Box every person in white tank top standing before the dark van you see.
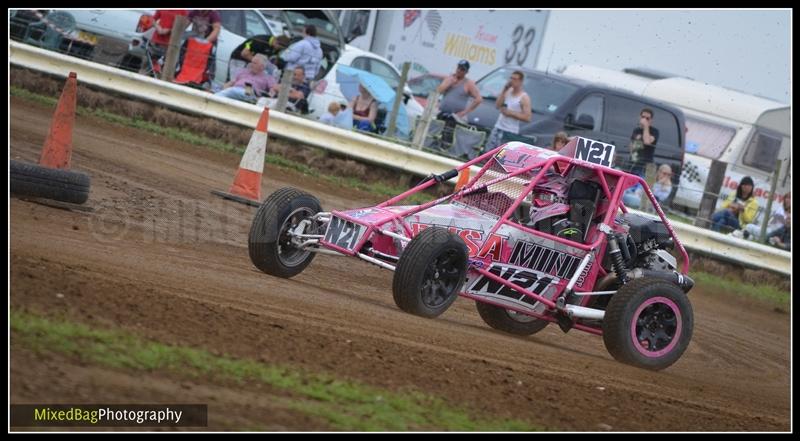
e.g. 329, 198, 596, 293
486, 70, 531, 150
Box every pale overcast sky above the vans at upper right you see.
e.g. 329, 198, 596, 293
537, 10, 791, 103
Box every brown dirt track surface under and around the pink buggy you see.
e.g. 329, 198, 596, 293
10, 98, 790, 431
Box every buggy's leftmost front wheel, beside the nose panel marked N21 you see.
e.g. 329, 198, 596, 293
252, 188, 322, 279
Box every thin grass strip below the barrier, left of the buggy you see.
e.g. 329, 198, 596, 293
10, 86, 432, 204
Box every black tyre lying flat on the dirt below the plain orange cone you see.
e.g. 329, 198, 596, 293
9, 160, 92, 204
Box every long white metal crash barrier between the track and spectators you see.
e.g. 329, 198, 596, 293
8, 41, 791, 275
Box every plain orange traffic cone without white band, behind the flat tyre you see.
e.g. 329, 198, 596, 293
39, 72, 78, 169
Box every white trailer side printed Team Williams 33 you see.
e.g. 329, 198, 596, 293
339, 9, 549, 79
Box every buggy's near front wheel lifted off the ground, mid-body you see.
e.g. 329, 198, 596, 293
392, 227, 469, 318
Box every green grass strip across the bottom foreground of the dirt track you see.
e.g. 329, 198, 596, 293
10, 310, 541, 431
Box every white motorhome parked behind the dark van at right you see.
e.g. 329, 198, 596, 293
562, 64, 792, 222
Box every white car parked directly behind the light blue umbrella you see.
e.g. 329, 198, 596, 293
308, 44, 425, 132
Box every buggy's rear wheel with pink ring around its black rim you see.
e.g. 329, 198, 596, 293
603, 278, 694, 370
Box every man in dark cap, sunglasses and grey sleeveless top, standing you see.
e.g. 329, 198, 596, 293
436, 60, 483, 144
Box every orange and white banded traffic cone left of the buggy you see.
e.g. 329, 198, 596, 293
211, 107, 269, 207
